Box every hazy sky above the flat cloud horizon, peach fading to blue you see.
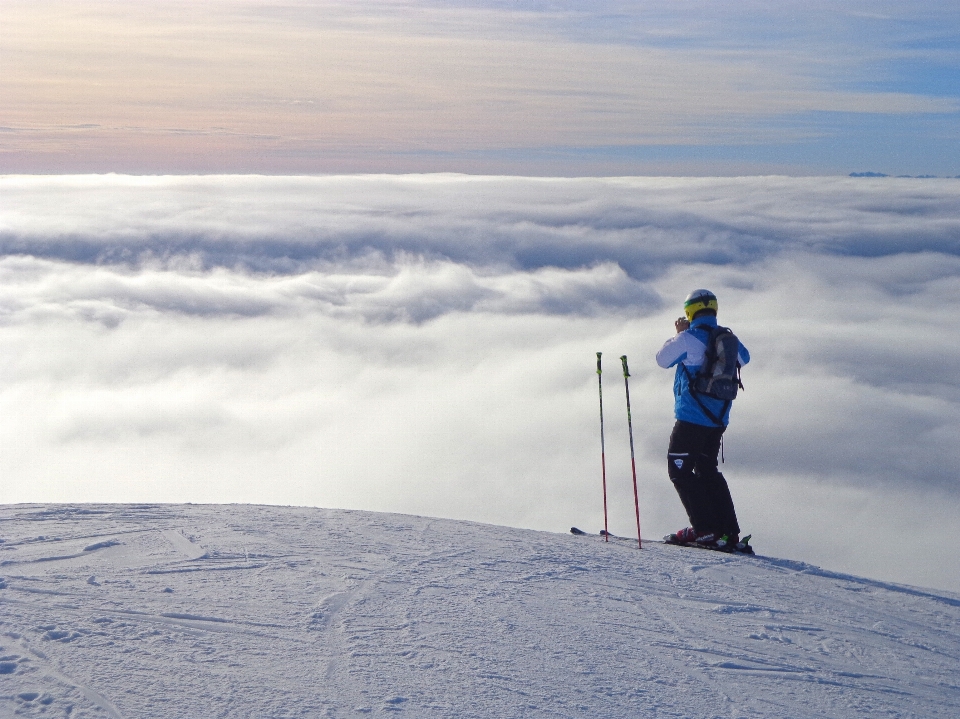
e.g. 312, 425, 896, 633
0, 0, 960, 176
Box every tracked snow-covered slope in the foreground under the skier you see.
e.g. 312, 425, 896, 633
0, 505, 960, 719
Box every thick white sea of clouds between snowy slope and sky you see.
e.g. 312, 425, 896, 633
0, 175, 960, 589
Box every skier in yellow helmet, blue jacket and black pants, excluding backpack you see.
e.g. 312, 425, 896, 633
657, 290, 750, 549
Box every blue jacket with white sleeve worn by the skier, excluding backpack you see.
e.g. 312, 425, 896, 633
657, 315, 750, 427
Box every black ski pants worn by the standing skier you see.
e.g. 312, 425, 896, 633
667, 420, 740, 538
